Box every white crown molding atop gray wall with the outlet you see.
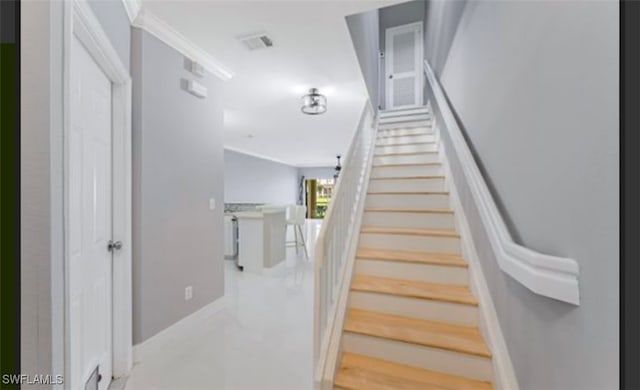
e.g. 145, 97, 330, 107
131, 8, 234, 80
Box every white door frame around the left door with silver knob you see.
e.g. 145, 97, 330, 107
62, 0, 133, 387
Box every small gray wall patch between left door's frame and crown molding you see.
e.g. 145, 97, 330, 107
88, 0, 131, 69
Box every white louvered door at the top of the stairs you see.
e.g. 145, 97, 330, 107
385, 22, 423, 109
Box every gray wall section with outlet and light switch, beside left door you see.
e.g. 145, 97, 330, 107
131, 28, 224, 344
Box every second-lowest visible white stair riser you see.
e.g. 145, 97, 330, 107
349, 291, 478, 326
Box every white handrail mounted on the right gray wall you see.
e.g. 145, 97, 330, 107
424, 60, 580, 305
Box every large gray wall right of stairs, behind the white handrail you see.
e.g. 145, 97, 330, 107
428, 1, 619, 390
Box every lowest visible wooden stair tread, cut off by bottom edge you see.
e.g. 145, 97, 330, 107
335, 352, 492, 390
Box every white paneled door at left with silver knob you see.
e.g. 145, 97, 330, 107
67, 36, 112, 390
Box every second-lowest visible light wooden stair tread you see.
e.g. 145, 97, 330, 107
344, 309, 491, 358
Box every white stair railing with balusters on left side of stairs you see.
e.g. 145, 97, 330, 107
313, 101, 376, 388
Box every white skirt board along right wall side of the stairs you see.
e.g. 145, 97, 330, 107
439, 142, 520, 390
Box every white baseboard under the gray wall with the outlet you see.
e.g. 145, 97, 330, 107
133, 296, 227, 363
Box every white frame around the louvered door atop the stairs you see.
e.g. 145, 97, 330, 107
384, 21, 424, 110
